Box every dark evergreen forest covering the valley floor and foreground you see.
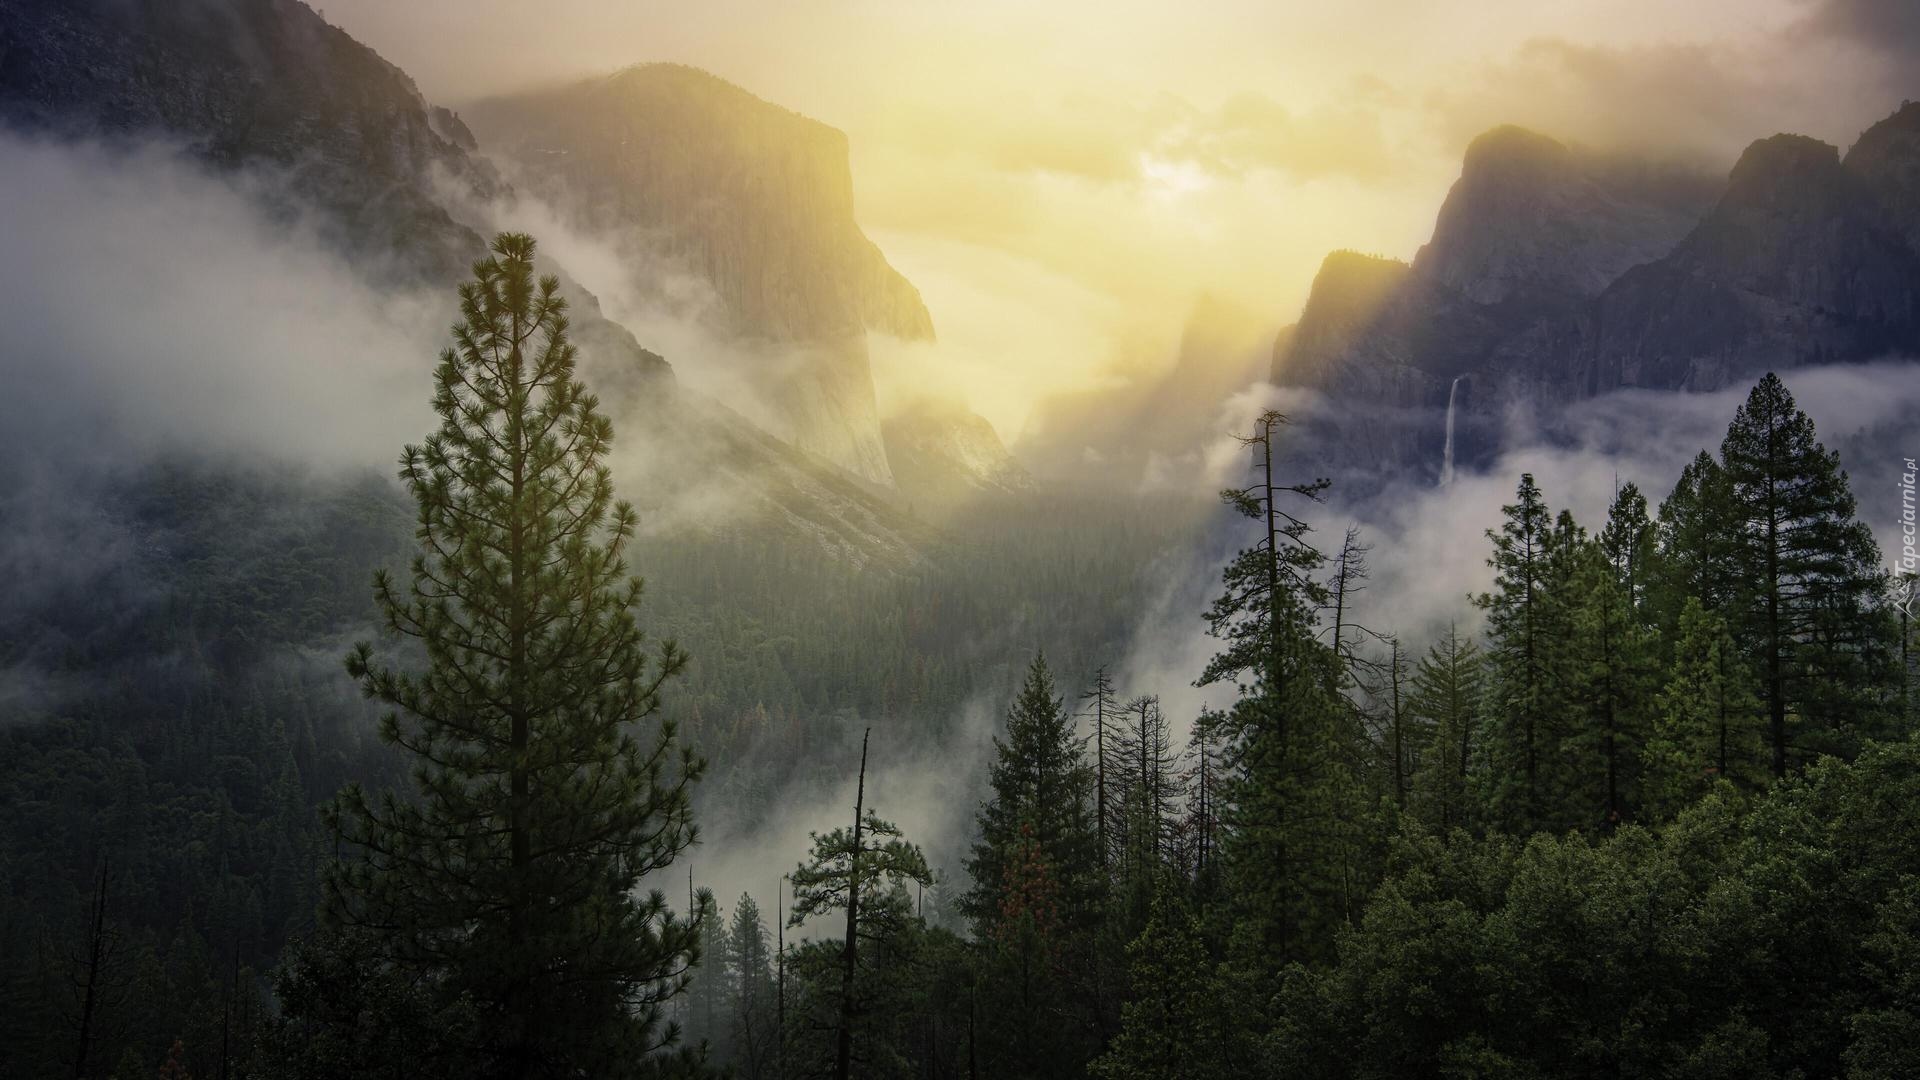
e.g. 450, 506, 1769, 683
0, 236, 1920, 1080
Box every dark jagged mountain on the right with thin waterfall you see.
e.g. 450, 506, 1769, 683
1273, 106, 1920, 479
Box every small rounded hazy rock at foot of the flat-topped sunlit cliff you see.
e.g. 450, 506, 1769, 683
881, 400, 1035, 511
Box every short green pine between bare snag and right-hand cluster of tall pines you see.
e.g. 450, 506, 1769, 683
1407, 625, 1484, 832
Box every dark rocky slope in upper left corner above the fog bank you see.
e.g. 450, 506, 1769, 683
0, 0, 499, 281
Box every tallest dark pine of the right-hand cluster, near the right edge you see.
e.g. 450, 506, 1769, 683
1720, 373, 1893, 776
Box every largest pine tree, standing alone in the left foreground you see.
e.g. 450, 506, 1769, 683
326, 234, 701, 1076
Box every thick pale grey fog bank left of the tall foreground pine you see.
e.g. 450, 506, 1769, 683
0, 136, 451, 465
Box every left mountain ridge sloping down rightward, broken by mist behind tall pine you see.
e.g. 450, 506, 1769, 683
0, 0, 927, 565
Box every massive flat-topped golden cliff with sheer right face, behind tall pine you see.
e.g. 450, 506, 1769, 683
465, 63, 933, 484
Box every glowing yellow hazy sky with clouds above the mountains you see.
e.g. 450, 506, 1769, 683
324, 0, 1920, 434
